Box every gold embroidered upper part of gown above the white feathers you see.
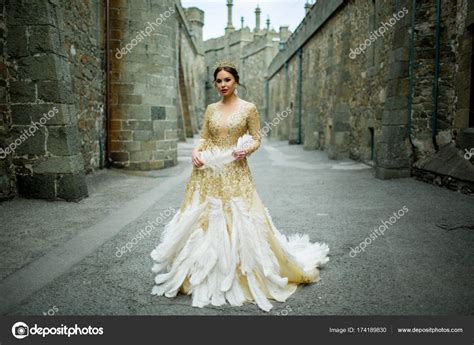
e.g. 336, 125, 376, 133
181, 100, 261, 210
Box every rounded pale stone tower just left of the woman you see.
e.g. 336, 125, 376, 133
110, 0, 178, 170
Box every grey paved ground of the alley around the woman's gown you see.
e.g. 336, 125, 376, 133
0, 138, 474, 315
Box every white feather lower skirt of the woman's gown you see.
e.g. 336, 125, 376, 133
151, 185, 329, 311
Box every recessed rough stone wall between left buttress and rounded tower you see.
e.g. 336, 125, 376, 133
58, 0, 106, 173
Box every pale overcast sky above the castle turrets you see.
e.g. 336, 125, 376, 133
181, 0, 315, 40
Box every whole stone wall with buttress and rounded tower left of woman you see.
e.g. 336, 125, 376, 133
0, 0, 204, 200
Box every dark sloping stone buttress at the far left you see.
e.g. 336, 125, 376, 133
2, 0, 87, 200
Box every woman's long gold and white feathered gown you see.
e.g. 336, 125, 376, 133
151, 100, 329, 311
